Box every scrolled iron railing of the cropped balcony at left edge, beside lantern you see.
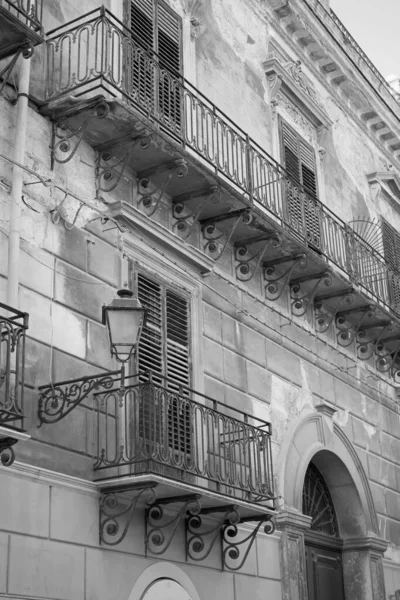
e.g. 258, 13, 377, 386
0, 303, 28, 429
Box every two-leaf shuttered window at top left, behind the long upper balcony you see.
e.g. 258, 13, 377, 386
125, 0, 182, 129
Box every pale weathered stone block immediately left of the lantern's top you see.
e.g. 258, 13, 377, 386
54, 261, 115, 321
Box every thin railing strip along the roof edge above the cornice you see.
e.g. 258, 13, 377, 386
305, 0, 400, 115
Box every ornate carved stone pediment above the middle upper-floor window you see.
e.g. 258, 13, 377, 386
263, 56, 332, 130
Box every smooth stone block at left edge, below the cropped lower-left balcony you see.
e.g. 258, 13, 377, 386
0, 474, 49, 537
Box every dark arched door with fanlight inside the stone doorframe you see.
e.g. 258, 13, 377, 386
303, 462, 344, 600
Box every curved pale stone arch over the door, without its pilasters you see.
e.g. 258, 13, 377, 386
277, 406, 379, 539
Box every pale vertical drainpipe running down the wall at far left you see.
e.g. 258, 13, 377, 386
7, 56, 31, 308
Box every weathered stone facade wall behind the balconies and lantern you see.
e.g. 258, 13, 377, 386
0, 0, 400, 600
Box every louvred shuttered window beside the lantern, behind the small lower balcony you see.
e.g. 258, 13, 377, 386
137, 273, 191, 454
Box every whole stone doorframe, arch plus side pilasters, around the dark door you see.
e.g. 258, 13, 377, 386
276, 404, 387, 600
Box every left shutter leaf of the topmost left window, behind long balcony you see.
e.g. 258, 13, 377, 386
128, 0, 155, 110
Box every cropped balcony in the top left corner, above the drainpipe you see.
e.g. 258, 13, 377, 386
0, 0, 44, 60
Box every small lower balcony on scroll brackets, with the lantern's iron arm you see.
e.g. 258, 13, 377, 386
39, 370, 275, 570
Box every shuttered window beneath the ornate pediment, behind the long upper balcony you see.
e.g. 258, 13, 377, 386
280, 119, 321, 249
